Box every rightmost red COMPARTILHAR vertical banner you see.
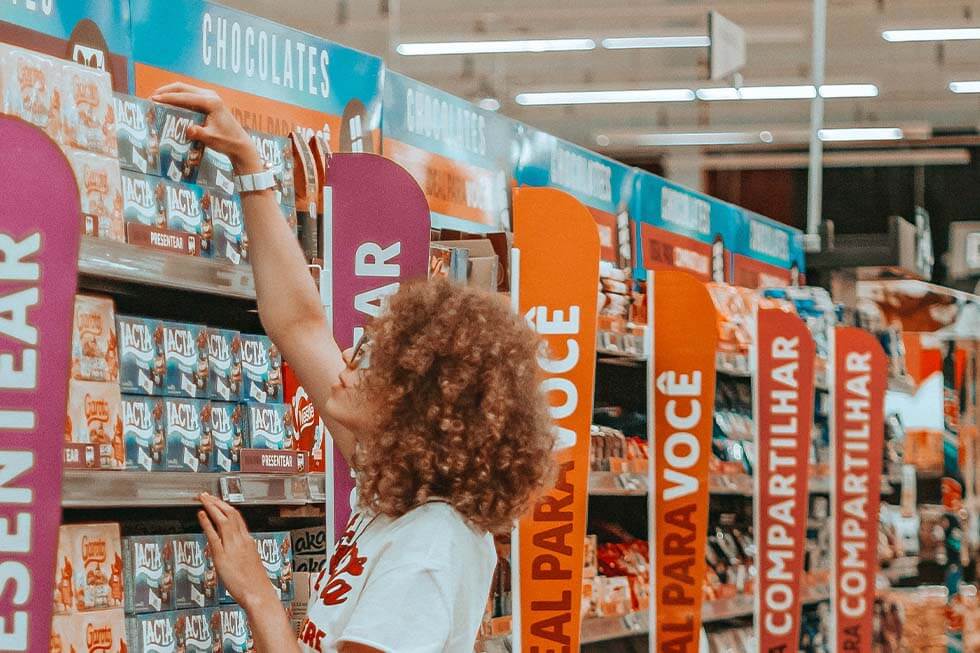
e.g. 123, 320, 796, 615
830, 327, 888, 653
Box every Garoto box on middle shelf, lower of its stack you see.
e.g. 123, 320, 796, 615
65, 379, 126, 469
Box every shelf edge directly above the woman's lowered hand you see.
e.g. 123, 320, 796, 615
61, 470, 310, 508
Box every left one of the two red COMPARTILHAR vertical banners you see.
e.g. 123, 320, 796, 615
753, 309, 815, 653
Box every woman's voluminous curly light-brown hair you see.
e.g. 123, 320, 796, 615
355, 279, 554, 533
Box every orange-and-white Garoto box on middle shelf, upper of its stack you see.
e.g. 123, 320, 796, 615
71, 295, 119, 382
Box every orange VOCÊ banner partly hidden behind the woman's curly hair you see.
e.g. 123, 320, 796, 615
513, 188, 599, 653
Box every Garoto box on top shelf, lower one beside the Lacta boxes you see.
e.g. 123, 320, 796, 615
68, 149, 126, 242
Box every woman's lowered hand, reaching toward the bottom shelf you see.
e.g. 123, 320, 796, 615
197, 492, 278, 610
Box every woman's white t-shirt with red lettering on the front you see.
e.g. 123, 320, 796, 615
299, 502, 497, 653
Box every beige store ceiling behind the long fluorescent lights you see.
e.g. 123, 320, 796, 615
225, 0, 980, 153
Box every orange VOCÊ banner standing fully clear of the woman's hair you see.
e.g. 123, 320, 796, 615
647, 271, 718, 653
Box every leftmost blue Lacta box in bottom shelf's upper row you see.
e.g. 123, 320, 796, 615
123, 535, 174, 614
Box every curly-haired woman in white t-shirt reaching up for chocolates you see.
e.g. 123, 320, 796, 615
153, 84, 554, 653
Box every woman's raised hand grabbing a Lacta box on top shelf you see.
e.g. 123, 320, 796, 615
150, 82, 263, 174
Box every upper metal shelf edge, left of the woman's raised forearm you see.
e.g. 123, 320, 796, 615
78, 236, 255, 299
